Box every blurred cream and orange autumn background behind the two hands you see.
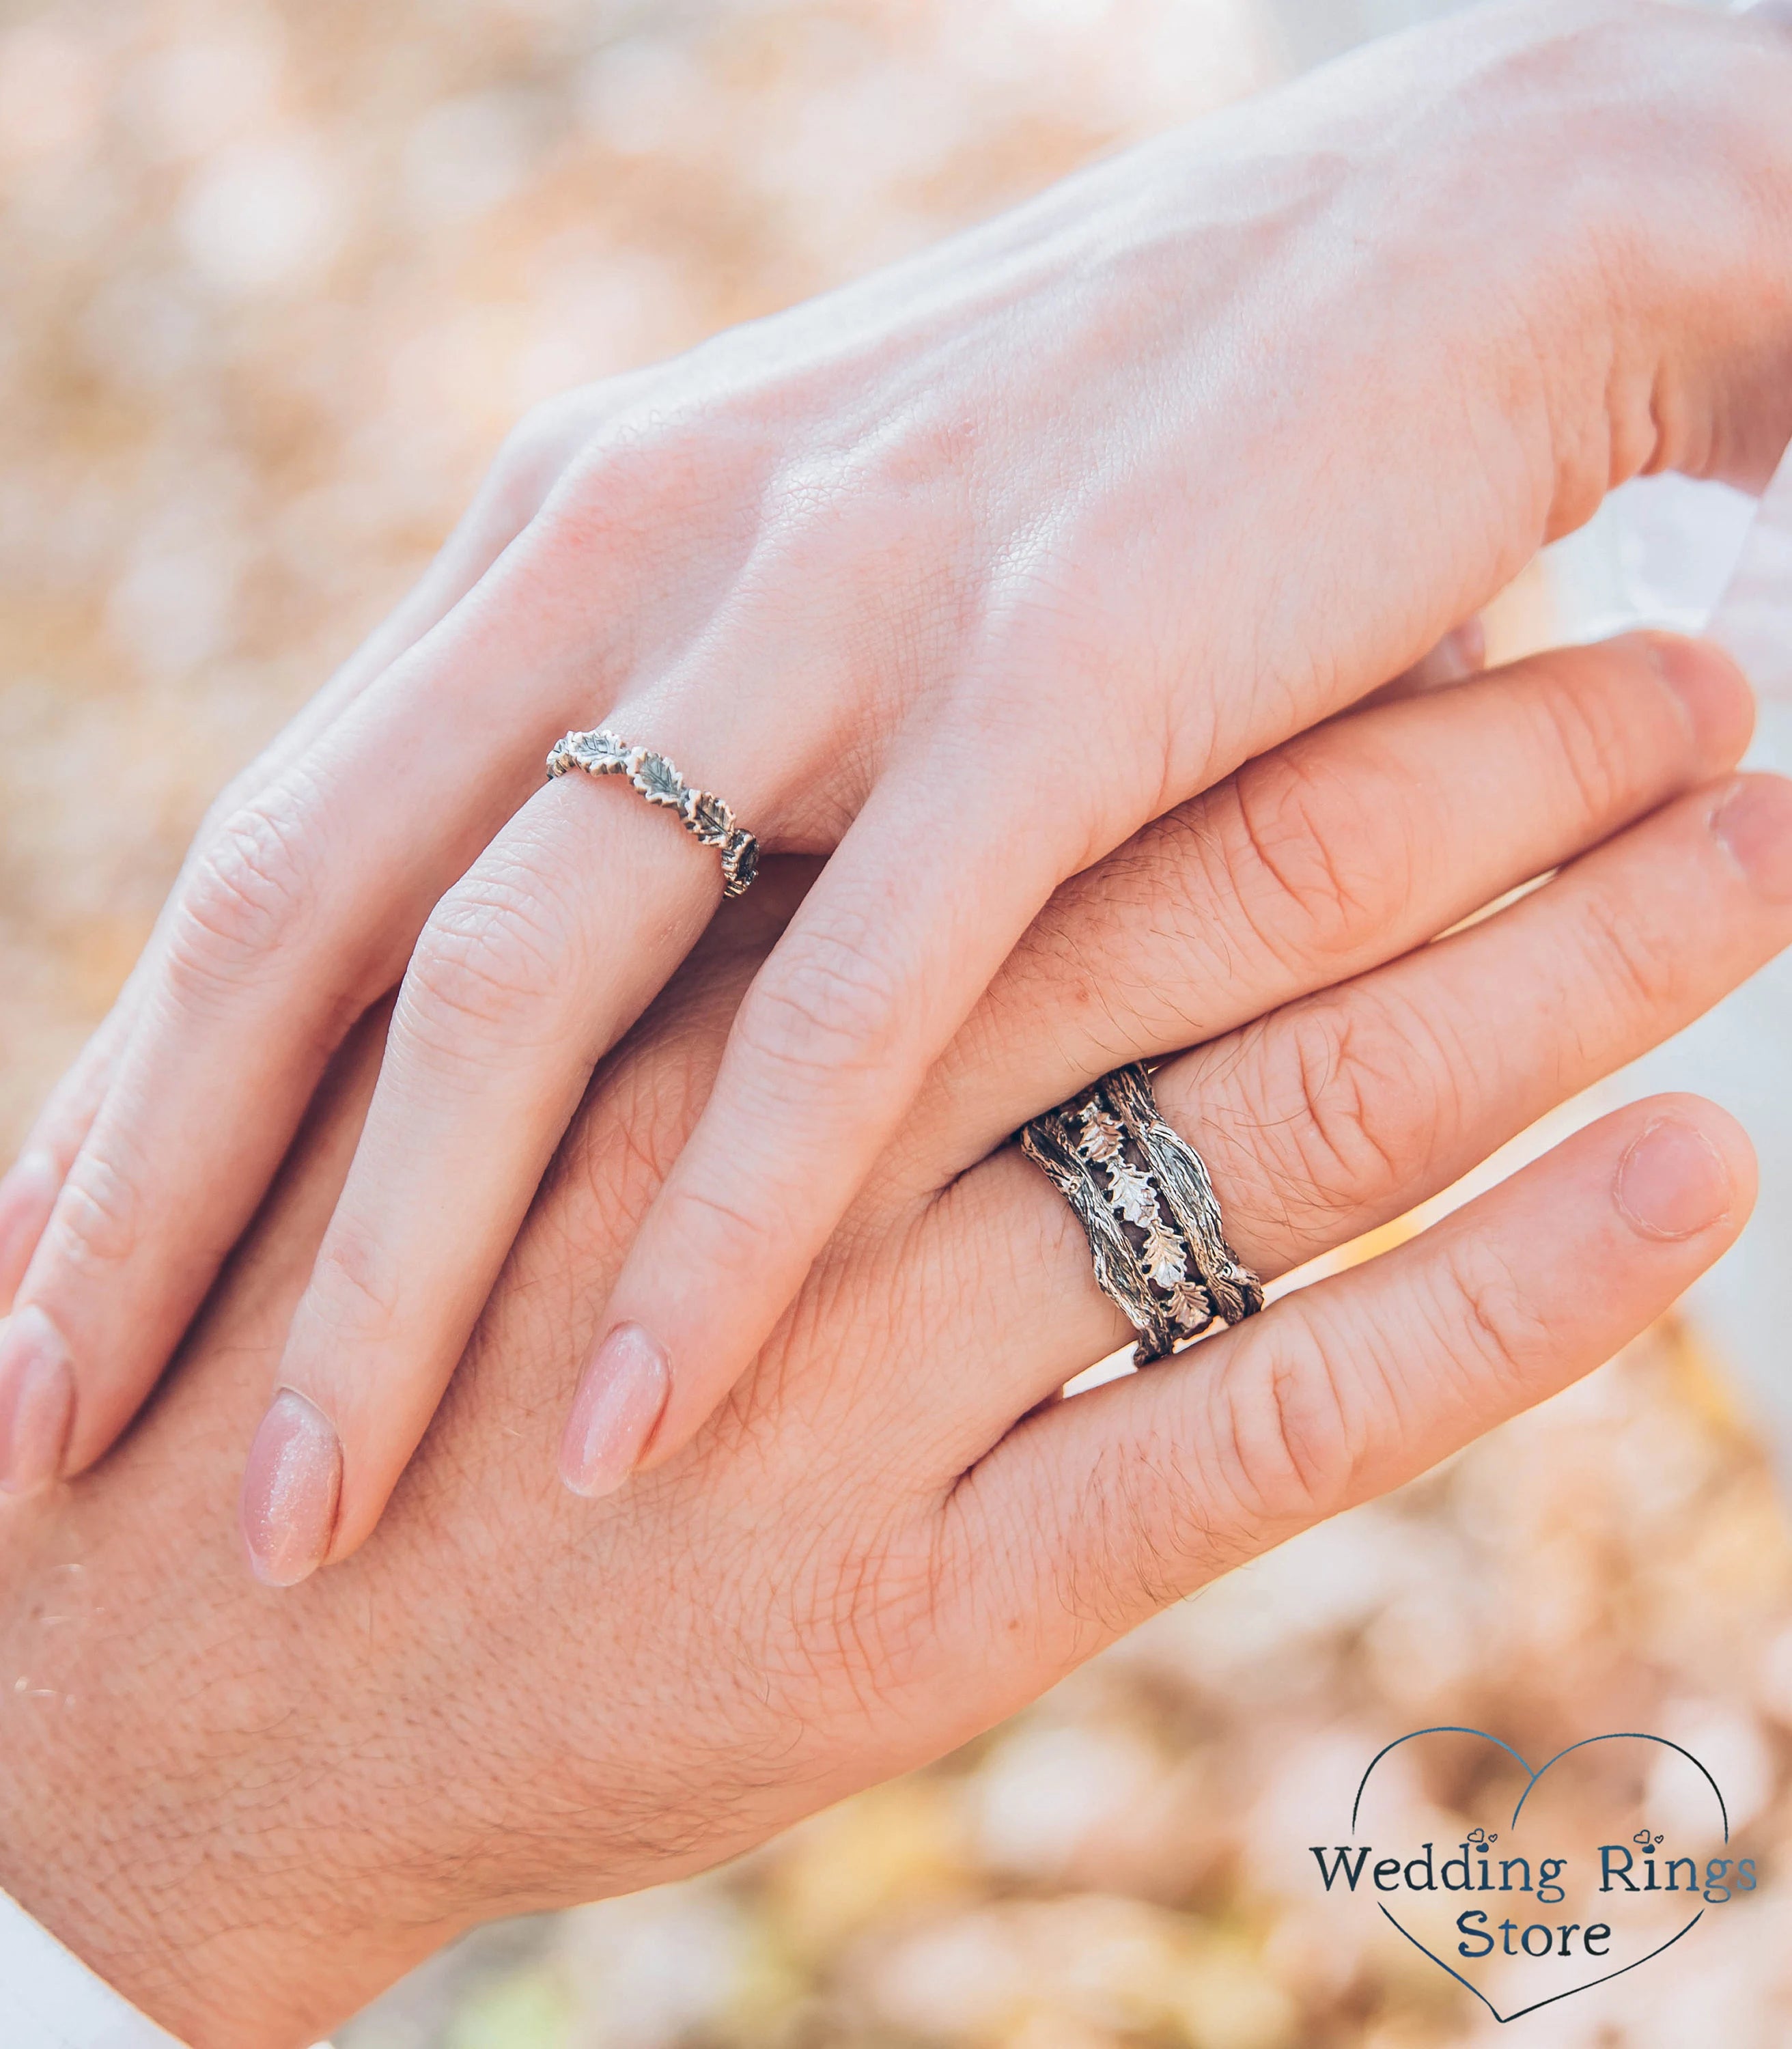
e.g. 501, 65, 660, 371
0, 0, 1792, 2049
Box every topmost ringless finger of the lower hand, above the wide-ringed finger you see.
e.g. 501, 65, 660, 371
883, 633, 1753, 1193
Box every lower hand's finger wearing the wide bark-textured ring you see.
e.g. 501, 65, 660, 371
932, 777, 1792, 1434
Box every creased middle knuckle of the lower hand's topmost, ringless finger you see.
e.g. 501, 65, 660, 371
1224, 746, 1415, 963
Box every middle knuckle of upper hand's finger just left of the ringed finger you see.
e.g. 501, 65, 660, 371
168, 797, 316, 988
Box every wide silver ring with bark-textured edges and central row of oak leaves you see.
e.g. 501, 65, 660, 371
1020, 1065, 1263, 1367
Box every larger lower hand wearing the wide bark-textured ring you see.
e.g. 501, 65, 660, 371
0, 637, 1792, 2049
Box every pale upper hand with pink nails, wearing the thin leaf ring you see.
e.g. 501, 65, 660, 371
0, 4, 1792, 1561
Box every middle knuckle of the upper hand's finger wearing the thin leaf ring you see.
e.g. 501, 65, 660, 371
397, 873, 563, 1051
